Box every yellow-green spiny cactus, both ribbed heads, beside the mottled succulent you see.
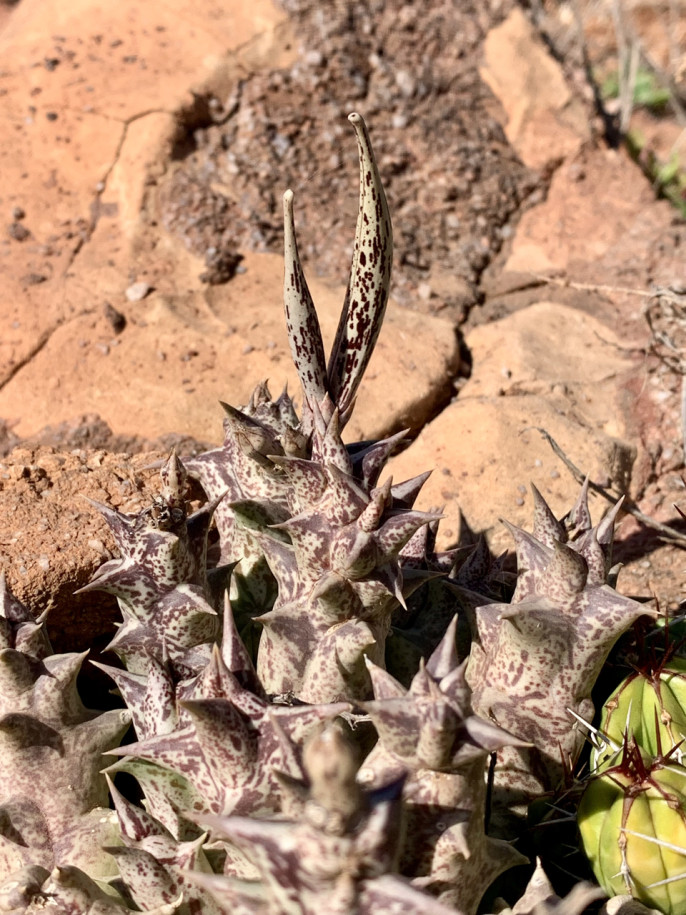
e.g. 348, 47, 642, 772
578, 628, 686, 915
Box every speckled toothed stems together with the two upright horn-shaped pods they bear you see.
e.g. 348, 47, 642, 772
184, 115, 436, 702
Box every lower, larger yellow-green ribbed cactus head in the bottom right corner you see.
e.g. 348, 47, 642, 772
578, 742, 686, 915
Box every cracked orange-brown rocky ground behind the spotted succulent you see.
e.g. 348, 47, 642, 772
0, 0, 686, 650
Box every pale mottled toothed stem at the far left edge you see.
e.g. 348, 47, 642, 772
0, 576, 130, 877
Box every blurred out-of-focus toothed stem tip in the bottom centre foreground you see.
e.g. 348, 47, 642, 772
189, 724, 462, 915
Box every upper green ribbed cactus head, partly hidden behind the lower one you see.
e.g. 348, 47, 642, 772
591, 658, 686, 771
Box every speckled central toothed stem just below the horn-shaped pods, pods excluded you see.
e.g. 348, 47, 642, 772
257, 415, 439, 702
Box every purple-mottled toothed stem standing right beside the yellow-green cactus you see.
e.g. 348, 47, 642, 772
467, 487, 656, 828
